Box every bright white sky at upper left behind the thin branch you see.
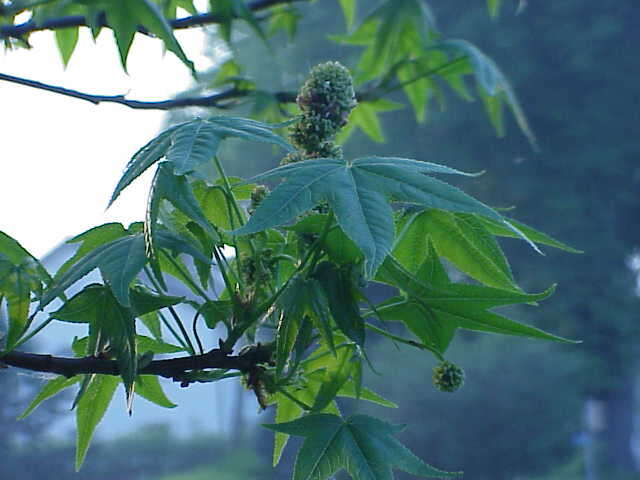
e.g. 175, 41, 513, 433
0, 23, 211, 257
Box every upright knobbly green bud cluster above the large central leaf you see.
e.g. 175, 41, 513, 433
282, 62, 357, 163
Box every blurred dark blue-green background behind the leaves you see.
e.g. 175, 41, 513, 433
0, 0, 640, 480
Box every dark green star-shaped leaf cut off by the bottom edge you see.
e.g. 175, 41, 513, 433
265, 414, 462, 480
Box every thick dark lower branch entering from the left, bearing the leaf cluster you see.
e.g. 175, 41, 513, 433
0, 345, 271, 381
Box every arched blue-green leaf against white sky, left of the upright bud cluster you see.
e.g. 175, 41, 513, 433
109, 116, 293, 205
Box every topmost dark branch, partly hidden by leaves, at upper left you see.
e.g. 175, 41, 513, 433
0, 0, 306, 39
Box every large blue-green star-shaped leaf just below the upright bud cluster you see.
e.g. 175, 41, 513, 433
232, 157, 503, 278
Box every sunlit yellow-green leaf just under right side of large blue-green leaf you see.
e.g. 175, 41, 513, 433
393, 209, 519, 290
